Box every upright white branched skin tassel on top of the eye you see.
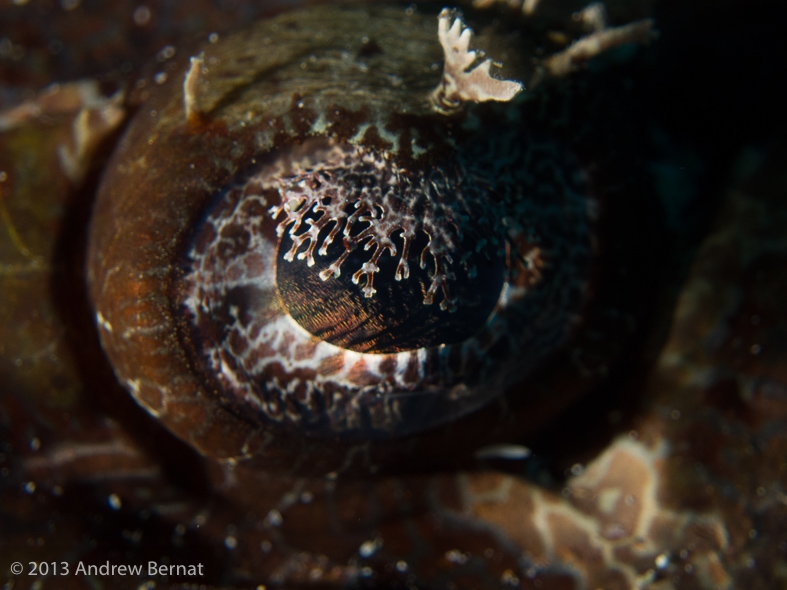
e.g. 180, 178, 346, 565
432, 8, 523, 113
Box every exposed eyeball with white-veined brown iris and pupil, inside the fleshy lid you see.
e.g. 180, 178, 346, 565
181, 129, 592, 437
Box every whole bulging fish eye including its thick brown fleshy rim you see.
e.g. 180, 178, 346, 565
88, 7, 652, 471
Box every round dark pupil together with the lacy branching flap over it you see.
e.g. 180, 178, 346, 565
273, 149, 506, 353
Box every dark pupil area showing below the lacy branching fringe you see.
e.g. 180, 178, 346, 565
276, 219, 505, 353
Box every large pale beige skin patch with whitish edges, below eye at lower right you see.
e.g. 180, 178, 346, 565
456, 436, 729, 588
